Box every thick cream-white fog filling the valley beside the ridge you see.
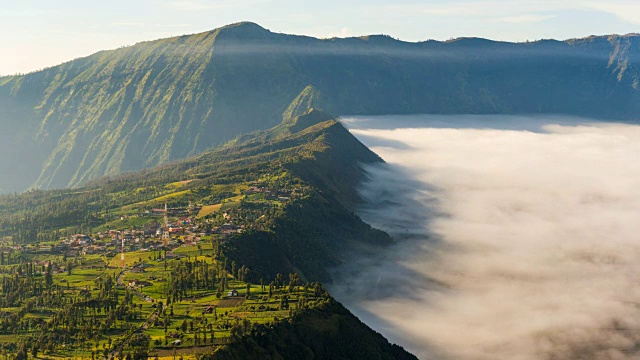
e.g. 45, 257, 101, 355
331, 116, 640, 360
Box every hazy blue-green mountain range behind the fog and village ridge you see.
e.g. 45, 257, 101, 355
0, 23, 640, 192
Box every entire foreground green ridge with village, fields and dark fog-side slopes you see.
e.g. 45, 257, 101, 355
0, 109, 414, 359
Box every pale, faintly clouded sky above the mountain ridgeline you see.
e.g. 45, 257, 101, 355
0, 0, 640, 75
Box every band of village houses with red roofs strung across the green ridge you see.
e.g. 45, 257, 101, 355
0, 186, 304, 273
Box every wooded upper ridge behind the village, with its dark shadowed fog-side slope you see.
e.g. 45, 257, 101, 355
0, 110, 390, 281
